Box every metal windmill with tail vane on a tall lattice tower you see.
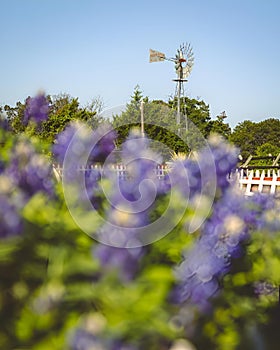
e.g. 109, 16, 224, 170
150, 43, 194, 129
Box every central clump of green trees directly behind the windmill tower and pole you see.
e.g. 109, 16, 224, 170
113, 85, 231, 160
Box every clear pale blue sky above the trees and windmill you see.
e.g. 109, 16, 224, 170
0, 0, 280, 127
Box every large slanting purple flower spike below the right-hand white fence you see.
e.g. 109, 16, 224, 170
173, 186, 276, 309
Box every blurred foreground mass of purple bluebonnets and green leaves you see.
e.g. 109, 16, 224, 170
0, 93, 280, 350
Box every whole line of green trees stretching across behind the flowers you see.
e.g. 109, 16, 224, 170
0, 85, 280, 159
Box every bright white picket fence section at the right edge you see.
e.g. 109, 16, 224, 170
237, 169, 280, 196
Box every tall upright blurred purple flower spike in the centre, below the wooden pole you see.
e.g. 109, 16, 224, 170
94, 133, 160, 280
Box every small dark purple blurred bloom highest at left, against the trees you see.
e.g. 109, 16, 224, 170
23, 93, 49, 125
